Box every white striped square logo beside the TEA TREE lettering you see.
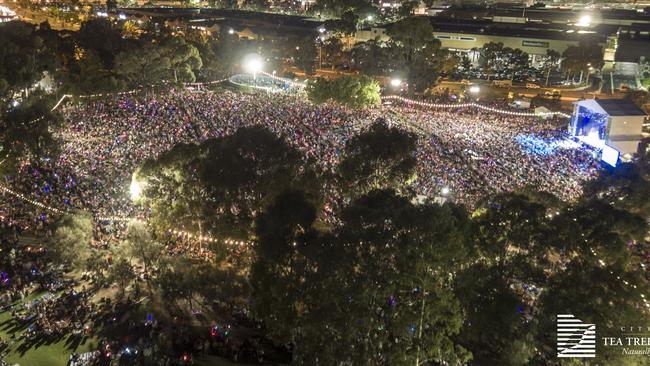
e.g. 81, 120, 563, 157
557, 314, 596, 358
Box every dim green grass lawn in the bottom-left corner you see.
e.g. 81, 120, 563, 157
0, 293, 97, 366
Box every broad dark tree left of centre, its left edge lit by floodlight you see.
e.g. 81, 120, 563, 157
138, 126, 320, 238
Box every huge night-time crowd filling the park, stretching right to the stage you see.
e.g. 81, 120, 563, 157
0, 90, 599, 233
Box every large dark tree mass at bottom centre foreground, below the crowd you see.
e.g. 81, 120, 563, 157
252, 191, 469, 365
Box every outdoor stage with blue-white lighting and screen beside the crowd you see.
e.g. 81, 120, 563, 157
569, 99, 646, 166
